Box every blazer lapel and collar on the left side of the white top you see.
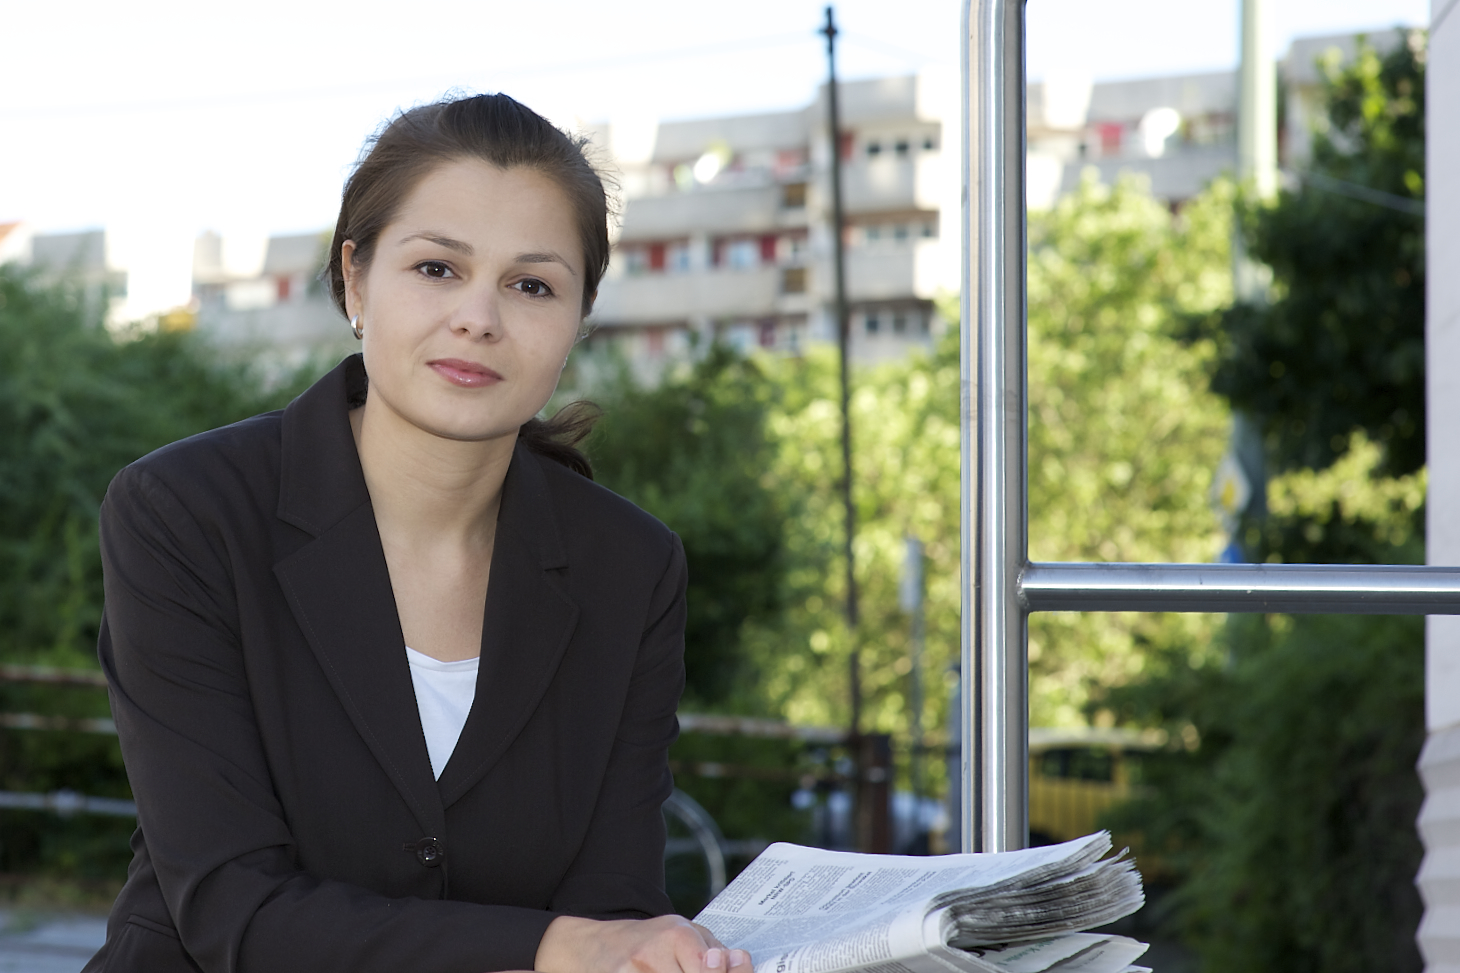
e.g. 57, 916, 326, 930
265, 356, 440, 834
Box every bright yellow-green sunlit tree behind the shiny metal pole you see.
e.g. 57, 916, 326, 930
749, 170, 1232, 733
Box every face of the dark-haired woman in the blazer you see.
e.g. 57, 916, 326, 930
343, 161, 584, 440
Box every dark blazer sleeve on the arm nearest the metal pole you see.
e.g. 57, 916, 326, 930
550, 535, 688, 919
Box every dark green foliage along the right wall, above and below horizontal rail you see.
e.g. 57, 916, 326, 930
1102, 34, 1425, 973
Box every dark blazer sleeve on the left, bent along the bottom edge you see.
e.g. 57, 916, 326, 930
99, 466, 557, 973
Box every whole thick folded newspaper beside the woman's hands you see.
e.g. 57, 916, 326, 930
695, 831, 1146, 973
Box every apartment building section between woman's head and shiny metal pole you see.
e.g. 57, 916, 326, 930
585, 76, 958, 371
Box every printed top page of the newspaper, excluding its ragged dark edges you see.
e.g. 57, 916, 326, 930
695, 834, 1127, 973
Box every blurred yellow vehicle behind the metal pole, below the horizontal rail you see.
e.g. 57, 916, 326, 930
1029, 726, 1165, 847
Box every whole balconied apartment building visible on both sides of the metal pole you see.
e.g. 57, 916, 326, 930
587, 31, 1402, 374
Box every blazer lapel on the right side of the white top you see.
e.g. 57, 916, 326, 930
438, 443, 578, 806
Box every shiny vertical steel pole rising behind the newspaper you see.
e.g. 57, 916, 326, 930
959, 0, 1029, 852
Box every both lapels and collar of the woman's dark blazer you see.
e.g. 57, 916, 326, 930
274, 355, 578, 834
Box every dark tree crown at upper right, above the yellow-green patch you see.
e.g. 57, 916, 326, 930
1213, 31, 1425, 475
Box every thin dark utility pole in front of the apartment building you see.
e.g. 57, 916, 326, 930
821, 6, 861, 718
